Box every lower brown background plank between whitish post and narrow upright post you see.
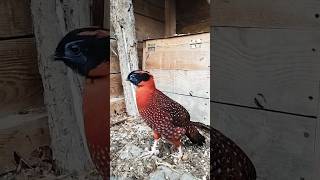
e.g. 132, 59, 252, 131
134, 14, 164, 41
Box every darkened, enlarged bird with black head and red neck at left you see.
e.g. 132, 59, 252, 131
55, 28, 110, 179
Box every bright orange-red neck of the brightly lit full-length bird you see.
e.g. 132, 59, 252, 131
136, 79, 156, 109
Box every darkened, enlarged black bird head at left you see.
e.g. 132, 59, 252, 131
55, 27, 110, 76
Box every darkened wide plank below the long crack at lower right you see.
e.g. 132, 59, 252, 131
211, 103, 318, 180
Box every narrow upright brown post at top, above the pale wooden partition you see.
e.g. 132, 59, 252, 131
164, 0, 177, 37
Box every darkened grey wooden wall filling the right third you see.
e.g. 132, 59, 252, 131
211, 0, 320, 180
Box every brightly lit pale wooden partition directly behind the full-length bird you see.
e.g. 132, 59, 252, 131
143, 33, 210, 125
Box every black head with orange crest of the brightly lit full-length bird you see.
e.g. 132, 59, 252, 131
127, 70, 154, 87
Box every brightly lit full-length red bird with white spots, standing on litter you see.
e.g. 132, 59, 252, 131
128, 71, 205, 158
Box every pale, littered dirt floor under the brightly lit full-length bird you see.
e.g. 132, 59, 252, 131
111, 117, 210, 180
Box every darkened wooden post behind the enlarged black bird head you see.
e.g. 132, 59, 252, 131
31, 0, 93, 173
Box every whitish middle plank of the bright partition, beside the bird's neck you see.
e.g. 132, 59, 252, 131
145, 69, 210, 99
